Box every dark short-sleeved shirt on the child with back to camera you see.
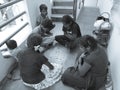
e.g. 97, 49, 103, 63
17, 48, 48, 84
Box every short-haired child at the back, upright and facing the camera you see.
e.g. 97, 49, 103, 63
36, 4, 49, 26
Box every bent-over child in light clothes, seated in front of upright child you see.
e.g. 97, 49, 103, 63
33, 19, 55, 52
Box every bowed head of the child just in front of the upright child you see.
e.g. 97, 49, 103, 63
41, 19, 55, 32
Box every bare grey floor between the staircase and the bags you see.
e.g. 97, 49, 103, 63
77, 7, 99, 35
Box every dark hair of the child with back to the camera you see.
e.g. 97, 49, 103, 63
27, 33, 42, 49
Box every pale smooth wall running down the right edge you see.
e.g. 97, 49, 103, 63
108, 0, 120, 90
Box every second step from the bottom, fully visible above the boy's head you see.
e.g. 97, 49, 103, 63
52, 6, 73, 14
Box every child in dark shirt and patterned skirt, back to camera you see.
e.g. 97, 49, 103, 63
17, 33, 62, 90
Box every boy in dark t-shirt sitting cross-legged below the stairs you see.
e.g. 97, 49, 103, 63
55, 15, 81, 49
